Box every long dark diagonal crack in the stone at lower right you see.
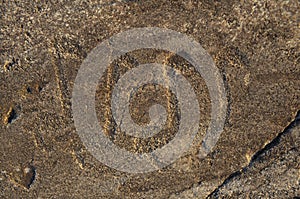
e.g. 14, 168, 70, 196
207, 110, 300, 198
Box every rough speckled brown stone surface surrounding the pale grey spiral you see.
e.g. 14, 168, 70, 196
0, 0, 300, 198
